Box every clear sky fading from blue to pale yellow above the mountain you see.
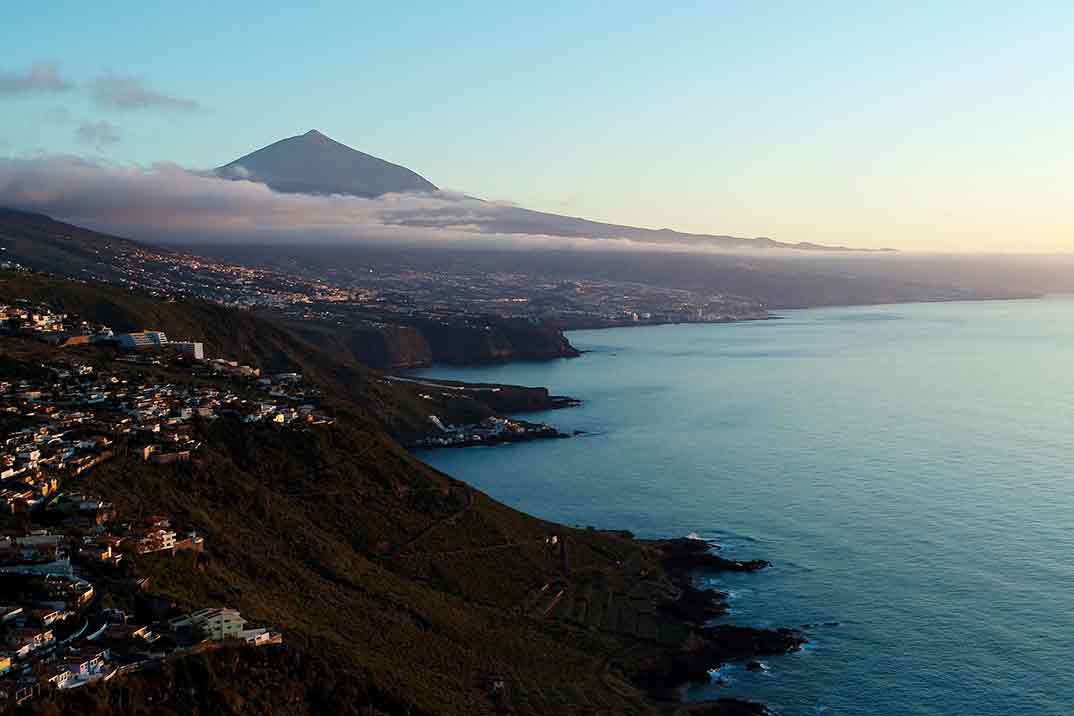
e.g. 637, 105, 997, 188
0, 0, 1074, 252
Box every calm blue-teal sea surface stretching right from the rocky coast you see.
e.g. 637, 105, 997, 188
414, 296, 1074, 716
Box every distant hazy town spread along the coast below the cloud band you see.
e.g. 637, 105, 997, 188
0, 226, 769, 328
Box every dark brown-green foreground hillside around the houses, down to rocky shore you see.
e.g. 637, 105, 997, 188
0, 283, 797, 716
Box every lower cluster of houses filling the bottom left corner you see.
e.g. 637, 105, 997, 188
0, 504, 282, 710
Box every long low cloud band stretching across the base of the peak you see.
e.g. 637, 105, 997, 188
0, 154, 790, 251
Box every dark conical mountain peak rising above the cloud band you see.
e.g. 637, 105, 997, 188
216, 129, 437, 198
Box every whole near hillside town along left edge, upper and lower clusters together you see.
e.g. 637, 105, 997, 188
0, 302, 332, 710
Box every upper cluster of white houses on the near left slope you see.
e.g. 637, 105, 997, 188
0, 296, 331, 512
